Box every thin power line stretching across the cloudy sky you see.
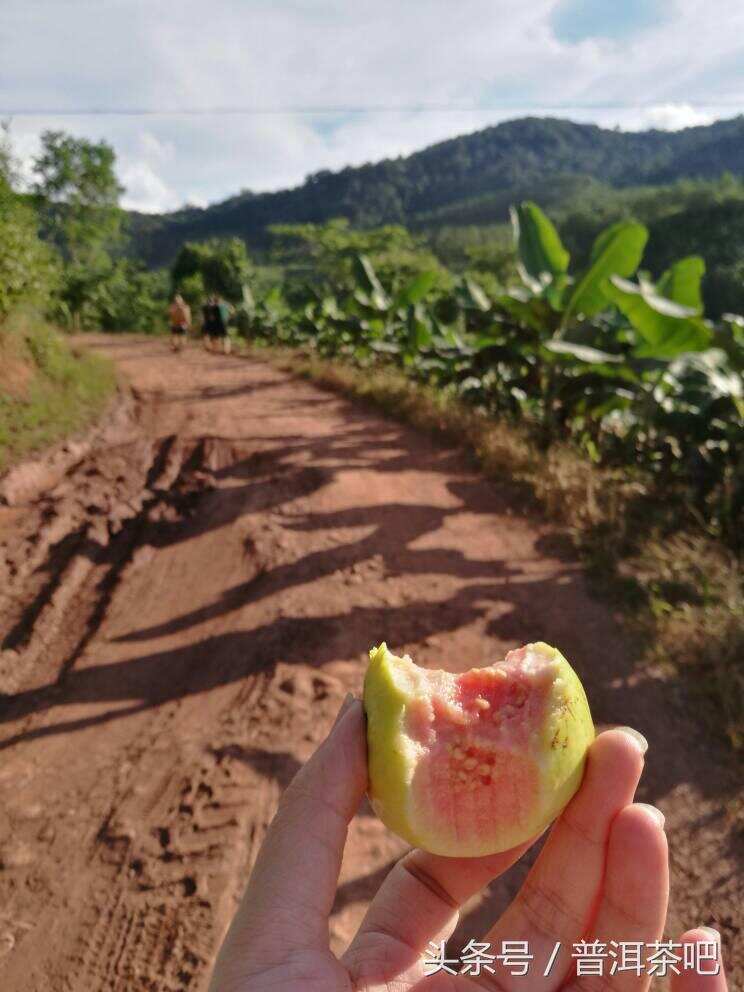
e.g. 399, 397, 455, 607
0, 98, 744, 117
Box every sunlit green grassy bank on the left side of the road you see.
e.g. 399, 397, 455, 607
0, 312, 116, 471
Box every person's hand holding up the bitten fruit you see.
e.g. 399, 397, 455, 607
210, 700, 727, 992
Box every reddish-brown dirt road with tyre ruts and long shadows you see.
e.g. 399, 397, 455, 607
0, 338, 744, 992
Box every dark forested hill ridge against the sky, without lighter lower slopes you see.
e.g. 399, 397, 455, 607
131, 116, 744, 264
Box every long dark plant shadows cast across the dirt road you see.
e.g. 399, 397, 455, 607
0, 384, 730, 816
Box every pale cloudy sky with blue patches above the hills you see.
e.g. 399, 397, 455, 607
0, 0, 744, 211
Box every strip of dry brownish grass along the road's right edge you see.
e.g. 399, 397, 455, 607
246, 347, 744, 749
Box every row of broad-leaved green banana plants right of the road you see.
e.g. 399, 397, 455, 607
245, 202, 744, 526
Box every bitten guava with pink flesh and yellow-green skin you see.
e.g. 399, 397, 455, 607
364, 643, 594, 857
